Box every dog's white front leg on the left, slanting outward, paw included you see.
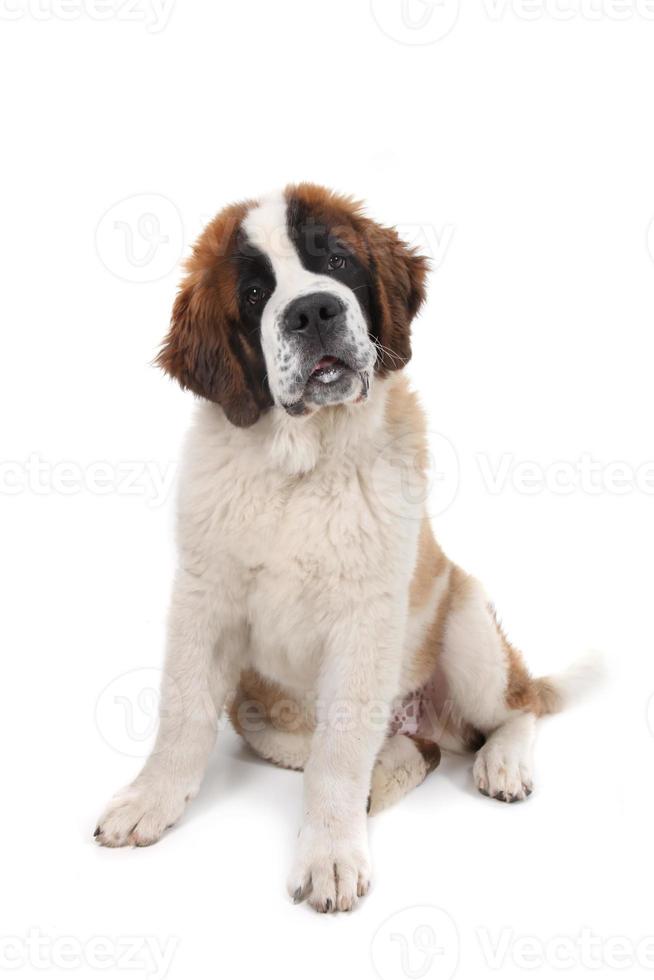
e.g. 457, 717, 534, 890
95, 571, 239, 847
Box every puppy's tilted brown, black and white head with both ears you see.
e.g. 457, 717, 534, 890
158, 184, 427, 426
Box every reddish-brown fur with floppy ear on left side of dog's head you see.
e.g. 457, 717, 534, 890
157, 201, 272, 426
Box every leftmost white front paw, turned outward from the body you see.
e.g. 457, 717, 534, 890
93, 782, 190, 847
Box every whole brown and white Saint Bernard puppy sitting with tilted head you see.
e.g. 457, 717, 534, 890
95, 184, 604, 912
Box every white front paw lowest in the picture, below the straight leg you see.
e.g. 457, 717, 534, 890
288, 825, 370, 912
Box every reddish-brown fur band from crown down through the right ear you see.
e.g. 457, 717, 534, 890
286, 183, 428, 376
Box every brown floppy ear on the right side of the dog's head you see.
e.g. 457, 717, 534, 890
368, 222, 429, 375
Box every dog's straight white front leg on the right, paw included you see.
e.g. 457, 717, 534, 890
288, 597, 402, 912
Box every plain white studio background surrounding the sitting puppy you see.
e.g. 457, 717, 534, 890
0, 0, 654, 980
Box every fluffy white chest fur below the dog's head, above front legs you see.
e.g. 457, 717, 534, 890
172, 374, 419, 690
